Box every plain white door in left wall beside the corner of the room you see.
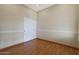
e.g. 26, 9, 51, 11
24, 17, 36, 41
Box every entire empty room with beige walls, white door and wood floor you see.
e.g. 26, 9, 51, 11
0, 4, 79, 55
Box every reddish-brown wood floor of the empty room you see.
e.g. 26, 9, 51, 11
0, 39, 79, 55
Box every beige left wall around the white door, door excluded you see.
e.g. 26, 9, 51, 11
0, 5, 36, 48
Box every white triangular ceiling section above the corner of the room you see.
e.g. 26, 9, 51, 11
25, 4, 54, 12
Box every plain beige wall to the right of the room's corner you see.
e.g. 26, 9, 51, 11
37, 4, 79, 48
